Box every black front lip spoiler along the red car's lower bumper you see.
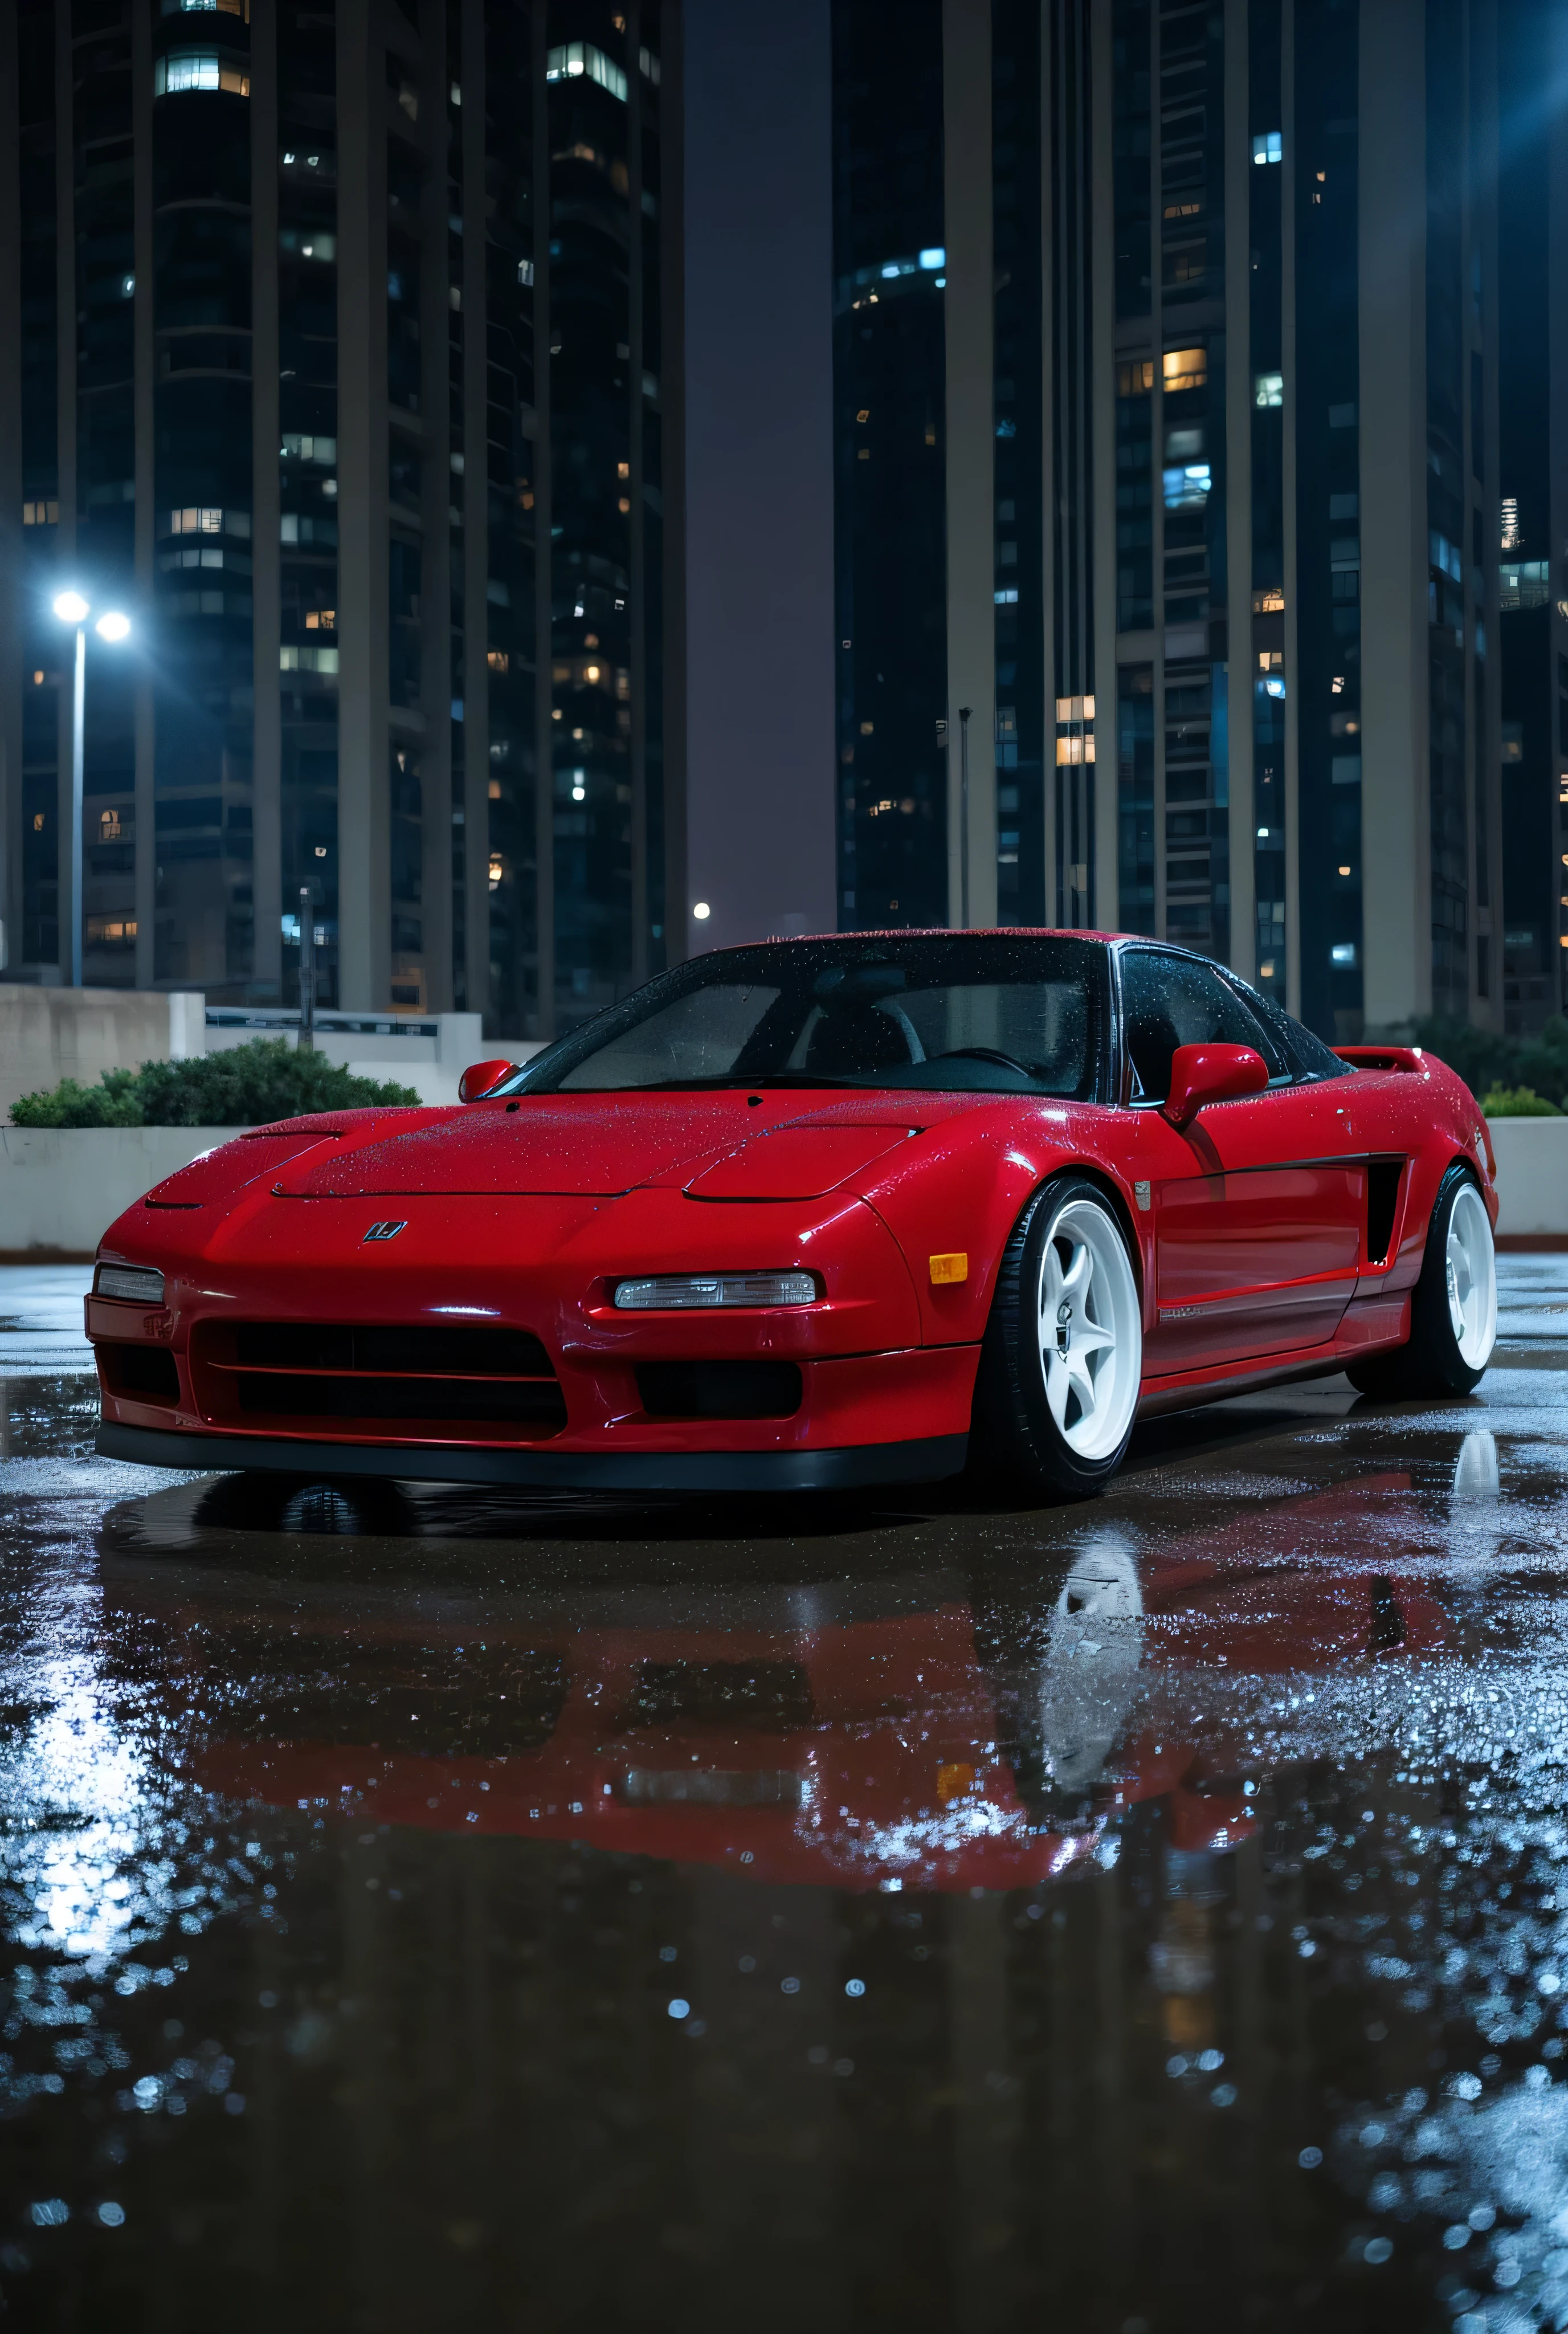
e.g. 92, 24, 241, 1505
98, 1424, 969, 1491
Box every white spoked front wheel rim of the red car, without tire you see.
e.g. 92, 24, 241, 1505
1036, 1193, 1144, 1461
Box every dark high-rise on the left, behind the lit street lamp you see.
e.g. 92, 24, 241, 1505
0, 0, 681, 1037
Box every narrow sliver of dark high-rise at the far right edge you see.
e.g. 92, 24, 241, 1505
1498, 0, 1568, 1037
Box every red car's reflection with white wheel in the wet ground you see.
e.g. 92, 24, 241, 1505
105, 1475, 1447, 1904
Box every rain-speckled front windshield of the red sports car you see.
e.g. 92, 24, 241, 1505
508, 933, 1108, 1099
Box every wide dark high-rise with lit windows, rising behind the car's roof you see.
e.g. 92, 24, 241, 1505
835, 0, 1521, 1041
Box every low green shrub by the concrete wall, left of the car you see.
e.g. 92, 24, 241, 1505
11, 1039, 420, 1127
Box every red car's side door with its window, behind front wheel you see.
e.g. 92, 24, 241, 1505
1120, 948, 1367, 1377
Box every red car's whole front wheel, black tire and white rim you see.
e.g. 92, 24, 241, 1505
971, 1174, 1144, 1501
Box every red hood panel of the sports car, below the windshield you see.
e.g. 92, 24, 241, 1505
273, 1092, 908, 1199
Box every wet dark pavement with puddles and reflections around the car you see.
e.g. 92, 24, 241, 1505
0, 1256, 1568, 2334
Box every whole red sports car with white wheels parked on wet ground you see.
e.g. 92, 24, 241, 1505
87, 931, 1498, 1496
